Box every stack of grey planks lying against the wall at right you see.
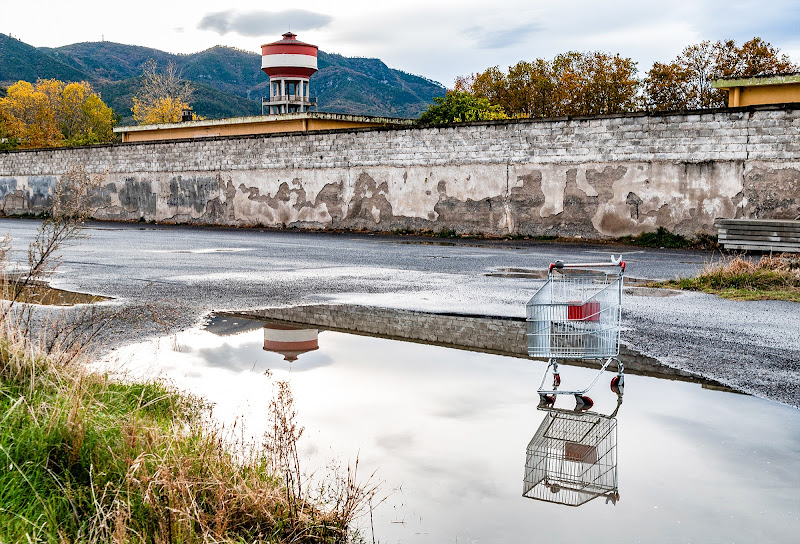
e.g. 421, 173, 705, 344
714, 219, 800, 253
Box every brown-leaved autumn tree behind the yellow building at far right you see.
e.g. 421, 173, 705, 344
644, 37, 800, 110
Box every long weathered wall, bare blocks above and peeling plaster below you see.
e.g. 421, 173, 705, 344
0, 105, 800, 237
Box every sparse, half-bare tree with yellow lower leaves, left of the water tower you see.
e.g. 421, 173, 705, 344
133, 59, 192, 125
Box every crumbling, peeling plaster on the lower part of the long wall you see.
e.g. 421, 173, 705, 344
0, 161, 788, 236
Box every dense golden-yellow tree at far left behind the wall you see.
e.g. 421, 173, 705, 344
0, 79, 115, 148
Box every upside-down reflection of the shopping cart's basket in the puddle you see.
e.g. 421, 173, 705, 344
522, 394, 622, 506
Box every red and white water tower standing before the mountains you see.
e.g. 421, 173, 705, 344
261, 32, 317, 115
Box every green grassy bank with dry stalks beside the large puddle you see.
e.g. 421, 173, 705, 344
0, 331, 359, 543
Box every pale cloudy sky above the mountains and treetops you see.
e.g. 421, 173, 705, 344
0, 0, 800, 87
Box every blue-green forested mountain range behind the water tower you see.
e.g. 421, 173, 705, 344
0, 34, 445, 124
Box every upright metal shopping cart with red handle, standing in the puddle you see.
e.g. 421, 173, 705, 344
526, 256, 625, 409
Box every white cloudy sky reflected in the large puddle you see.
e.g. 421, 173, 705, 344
104, 320, 800, 542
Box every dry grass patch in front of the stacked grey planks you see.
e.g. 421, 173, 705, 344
658, 254, 800, 302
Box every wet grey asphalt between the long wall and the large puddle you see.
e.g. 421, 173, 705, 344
0, 219, 800, 407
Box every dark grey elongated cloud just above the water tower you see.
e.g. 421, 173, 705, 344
197, 9, 333, 37
